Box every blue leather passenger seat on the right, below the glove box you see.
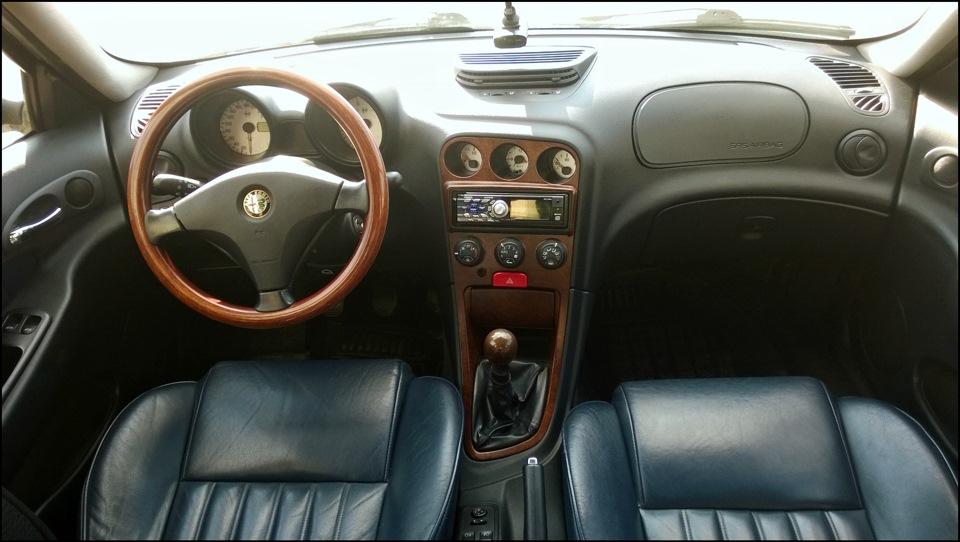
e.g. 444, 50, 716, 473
563, 377, 957, 540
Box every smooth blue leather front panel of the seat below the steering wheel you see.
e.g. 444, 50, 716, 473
183, 360, 413, 482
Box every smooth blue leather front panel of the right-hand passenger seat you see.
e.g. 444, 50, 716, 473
613, 377, 861, 510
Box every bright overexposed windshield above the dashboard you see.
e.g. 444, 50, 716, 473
59, 2, 928, 62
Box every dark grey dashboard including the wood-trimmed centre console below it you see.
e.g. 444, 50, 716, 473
95, 31, 956, 460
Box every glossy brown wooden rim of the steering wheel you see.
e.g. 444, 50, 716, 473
127, 68, 389, 328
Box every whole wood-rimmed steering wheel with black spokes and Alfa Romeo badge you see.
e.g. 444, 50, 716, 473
127, 68, 388, 328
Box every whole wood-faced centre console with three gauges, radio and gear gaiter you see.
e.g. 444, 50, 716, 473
440, 136, 580, 461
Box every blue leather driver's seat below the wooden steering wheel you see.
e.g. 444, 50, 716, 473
81, 360, 463, 539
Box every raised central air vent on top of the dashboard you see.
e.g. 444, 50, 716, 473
457, 47, 596, 89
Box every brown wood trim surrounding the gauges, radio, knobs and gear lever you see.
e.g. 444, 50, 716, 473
440, 136, 580, 461
